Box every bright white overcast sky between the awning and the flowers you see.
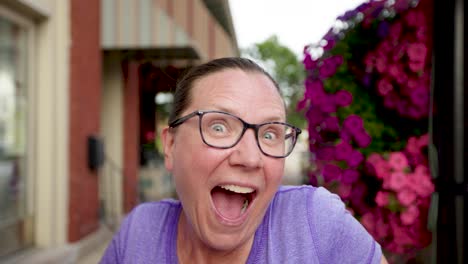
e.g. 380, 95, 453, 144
229, 0, 365, 58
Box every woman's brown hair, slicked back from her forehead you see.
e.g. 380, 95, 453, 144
168, 57, 280, 124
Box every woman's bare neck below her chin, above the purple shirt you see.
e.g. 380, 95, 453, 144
177, 211, 254, 263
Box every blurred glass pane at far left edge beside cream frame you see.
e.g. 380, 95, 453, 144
0, 5, 33, 258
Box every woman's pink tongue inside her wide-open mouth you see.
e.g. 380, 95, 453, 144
211, 188, 245, 219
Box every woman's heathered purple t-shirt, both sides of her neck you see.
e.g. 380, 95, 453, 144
100, 186, 382, 263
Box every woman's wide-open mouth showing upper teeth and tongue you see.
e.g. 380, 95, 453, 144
211, 184, 256, 220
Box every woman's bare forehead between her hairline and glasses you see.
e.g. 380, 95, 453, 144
189, 69, 285, 120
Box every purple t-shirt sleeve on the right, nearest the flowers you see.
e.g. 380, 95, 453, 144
308, 188, 382, 264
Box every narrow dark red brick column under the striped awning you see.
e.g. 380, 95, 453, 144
122, 61, 140, 212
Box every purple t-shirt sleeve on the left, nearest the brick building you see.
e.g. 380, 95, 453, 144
99, 209, 133, 264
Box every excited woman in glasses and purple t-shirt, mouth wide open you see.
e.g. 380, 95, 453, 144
101, 58, 384, 263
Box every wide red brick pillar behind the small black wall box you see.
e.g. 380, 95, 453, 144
68, 0, 101, 242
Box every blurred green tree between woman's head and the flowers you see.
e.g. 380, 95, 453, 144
242, 35, 306, 128
